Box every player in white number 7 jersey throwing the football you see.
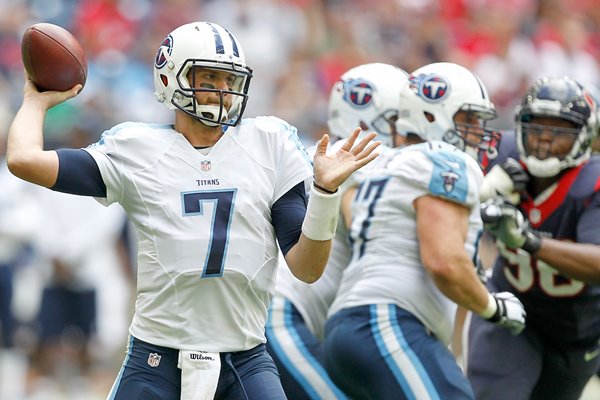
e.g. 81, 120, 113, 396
7, 22, 379, 400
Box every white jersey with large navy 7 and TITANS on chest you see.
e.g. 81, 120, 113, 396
87, 117, 312, 352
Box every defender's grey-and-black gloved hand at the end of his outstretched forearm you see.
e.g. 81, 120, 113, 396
481, 198, 541, 254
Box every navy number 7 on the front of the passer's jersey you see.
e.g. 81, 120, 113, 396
181, 189, 236, 278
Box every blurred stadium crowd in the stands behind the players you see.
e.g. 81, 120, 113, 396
0, 0, 600, 399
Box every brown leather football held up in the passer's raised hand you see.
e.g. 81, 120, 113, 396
21, 23, 87, 92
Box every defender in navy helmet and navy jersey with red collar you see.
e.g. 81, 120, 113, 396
466, 76, 600, 400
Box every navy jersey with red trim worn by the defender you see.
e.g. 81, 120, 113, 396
490, 133, 600, 346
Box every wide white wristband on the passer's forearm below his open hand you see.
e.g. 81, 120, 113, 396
302, 186, 341, 241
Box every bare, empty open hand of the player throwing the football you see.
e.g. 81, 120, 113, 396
313, 128, 381, 192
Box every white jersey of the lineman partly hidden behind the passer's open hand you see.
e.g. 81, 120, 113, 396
276, 140, 391, 339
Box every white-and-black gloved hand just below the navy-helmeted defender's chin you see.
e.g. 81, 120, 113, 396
479, 158, 529, 204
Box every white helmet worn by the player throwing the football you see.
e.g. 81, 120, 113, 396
154, 22, 252, 126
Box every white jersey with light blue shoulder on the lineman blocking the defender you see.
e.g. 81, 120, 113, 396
329, 142, 483, 344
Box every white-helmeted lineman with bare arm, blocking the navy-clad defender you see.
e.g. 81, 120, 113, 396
325, 63, 525, 400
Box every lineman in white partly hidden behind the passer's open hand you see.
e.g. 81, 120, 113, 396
266, 63, 408, 400
